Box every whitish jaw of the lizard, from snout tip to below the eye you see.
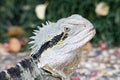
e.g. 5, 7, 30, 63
57, 28, 96, 53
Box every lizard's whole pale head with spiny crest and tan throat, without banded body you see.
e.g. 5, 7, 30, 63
32, 14, 95, 80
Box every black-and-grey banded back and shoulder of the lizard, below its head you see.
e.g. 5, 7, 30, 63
0, 57, 60, 80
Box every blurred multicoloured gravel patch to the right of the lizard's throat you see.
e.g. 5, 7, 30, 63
72, 48, 120, 80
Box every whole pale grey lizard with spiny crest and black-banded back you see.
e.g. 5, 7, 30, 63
0, 14, 96, 80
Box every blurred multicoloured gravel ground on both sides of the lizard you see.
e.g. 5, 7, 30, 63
0, 49, 120, 80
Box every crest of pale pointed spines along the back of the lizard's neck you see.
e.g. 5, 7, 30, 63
29, 21, 54, 54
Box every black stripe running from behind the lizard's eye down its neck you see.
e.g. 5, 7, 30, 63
31, 32, 68, 59
